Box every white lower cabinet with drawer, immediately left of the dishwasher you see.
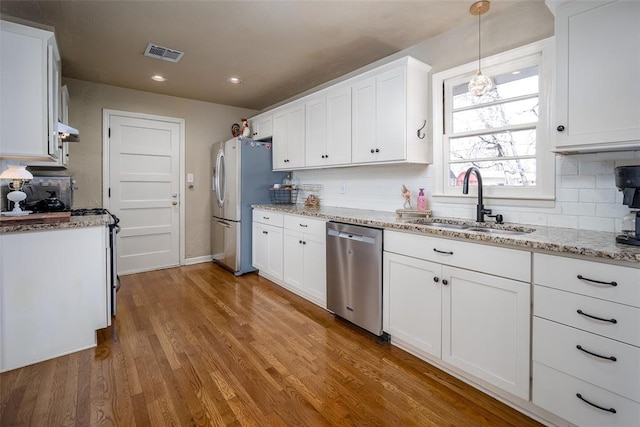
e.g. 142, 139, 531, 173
283, 215, 327, 307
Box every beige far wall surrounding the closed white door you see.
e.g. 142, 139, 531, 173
63, 78, 253, 259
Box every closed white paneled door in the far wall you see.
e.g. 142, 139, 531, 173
104, 111, 184, 274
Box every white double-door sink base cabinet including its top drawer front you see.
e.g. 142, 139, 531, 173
383, 231, 531, 400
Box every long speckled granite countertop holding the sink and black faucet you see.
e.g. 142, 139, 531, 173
253, 204, 640, 263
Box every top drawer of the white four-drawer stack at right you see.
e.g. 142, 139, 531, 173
533, 254, 640, 307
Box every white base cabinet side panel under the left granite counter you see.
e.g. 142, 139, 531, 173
0, 226, 111, 372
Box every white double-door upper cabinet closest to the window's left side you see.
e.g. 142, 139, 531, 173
352, 57, 431, 164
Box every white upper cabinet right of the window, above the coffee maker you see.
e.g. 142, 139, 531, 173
554, 1, 640, 153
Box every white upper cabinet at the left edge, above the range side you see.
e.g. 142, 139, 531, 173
0, 21, 62, 165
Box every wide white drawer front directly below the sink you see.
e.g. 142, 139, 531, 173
384, 230, 531, 282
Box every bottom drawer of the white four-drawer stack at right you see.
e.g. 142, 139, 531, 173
533, 362, 640, 427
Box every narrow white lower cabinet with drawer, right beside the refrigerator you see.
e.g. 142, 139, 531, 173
251, 210, 283, 280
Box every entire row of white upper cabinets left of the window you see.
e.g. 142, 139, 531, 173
264, 56, 431, 170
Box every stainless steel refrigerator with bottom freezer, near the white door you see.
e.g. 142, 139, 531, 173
211, 138, 286, 276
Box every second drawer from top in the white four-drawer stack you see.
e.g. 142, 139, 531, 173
533, 285, 640, 346
